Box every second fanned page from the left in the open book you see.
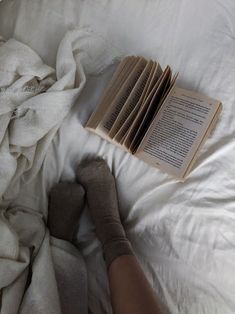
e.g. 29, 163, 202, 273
97, 58, 147, 134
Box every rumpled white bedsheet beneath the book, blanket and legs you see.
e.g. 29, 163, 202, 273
0, 0, 235, 314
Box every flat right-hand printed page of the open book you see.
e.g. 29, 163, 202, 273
135, 87, 221, 179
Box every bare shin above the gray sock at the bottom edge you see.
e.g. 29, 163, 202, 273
108, 255, 162, 314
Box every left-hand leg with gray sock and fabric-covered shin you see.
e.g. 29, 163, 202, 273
48, 183, 88, 314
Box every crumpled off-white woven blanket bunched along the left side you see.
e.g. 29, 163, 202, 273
0, 30, 120, 314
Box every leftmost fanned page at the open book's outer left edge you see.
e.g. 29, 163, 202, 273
86, 56, 140, 129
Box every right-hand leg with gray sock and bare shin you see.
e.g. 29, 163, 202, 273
77, 159, 161, 314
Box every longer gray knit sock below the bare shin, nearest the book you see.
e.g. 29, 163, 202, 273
77, 159, 133, 267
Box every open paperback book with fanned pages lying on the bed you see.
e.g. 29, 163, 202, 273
86, 56, 222, 180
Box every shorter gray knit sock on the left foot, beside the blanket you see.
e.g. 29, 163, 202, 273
48, 183, 85, 242
